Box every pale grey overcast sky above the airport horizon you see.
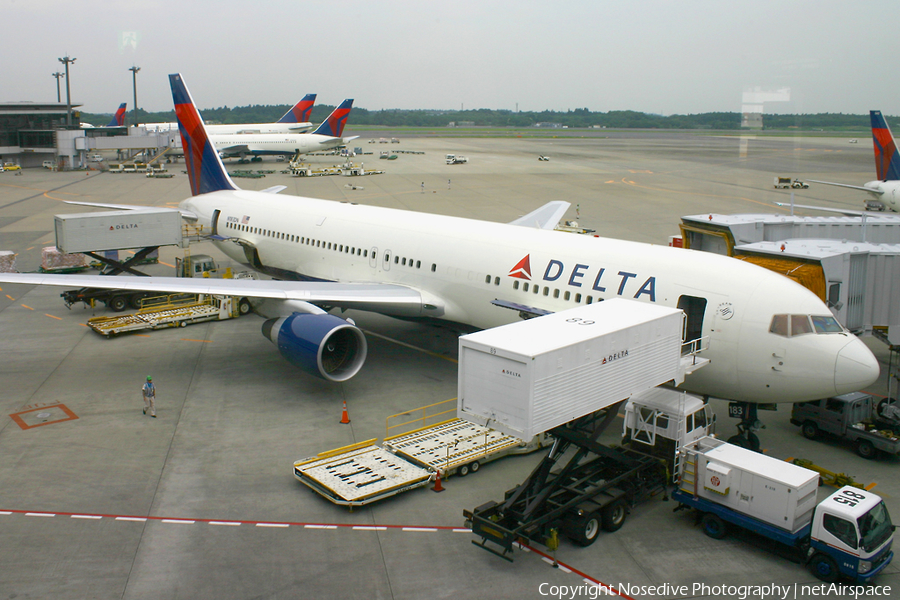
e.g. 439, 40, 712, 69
7, 0, 900, 115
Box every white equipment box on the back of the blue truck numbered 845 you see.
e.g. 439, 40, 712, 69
679, 437, 819, 533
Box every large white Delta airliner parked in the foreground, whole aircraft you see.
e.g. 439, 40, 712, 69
0, 74, 879, 446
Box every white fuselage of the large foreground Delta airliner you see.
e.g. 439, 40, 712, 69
182, 190, 879, 402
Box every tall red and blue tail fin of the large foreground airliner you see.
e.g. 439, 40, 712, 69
169, 73, 238, 196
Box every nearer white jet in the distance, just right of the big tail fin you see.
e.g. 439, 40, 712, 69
207, 98, 357, 160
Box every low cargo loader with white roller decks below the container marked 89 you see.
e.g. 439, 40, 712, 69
294, 419, 546, 509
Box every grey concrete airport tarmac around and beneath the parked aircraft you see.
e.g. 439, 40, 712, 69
0, 131, 900, 600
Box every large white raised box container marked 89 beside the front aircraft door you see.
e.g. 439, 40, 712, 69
457, 299, 684, 440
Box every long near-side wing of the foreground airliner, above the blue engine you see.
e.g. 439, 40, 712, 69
0, 273, 425, 316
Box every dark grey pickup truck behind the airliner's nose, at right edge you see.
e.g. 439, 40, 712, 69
791, 392, 900, 458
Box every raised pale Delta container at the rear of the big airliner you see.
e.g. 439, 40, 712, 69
54, 208, 182, 253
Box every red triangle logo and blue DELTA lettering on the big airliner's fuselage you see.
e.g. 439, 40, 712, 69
509, 254, 656, 302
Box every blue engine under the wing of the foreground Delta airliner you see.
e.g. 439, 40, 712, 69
262, 313, 366, 381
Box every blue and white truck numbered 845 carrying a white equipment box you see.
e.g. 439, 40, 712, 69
672, 437, 894, 583
